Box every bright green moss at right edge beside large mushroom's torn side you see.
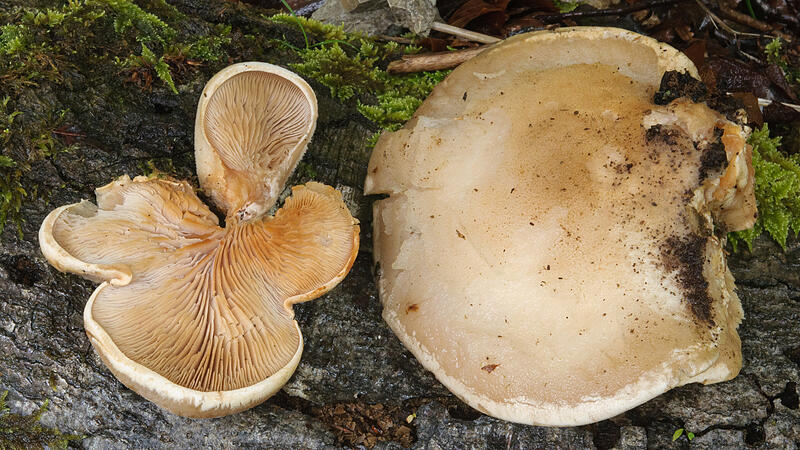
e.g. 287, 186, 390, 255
728, 124, 800, 251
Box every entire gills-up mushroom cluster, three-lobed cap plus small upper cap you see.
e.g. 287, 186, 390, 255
39, 63, 359, 417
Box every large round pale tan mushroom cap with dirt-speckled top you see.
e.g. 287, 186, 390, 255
365, 27, 755, 426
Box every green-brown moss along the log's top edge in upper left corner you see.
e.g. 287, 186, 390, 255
0, 0, 230, 88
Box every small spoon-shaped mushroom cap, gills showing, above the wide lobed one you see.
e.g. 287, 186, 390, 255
195, 63, 317, 220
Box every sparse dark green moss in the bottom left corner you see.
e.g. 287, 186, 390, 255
0, 391, 83, 449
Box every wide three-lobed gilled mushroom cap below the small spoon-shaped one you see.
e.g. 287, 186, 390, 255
40, 176, 358, 417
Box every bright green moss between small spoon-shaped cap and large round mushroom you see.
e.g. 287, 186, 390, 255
271, 14, 450, 131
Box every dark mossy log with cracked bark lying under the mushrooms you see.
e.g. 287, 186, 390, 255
0, 0, 800, 448
